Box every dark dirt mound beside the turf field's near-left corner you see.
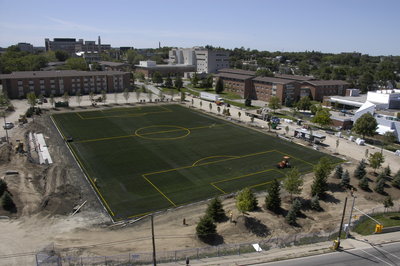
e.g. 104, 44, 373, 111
40, 184, 81, 215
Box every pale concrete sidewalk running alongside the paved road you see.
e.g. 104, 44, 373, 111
162, 232, 400, 265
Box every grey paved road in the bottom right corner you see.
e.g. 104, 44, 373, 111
258, 243, 400, 266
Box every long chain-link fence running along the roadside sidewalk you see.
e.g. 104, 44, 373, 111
36, 206, 400, 266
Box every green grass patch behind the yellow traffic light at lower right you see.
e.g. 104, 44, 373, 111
353, 212, 400, 235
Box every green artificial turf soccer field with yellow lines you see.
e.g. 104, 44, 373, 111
53, 105, 339, 220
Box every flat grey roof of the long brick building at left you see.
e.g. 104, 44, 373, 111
0, 70, 126, 79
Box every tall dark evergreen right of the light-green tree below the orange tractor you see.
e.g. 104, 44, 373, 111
311, 157, 333, 197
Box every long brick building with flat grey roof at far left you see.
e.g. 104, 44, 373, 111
0, 70, 130, 99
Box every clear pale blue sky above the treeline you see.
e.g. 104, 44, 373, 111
0, 0, 400, 55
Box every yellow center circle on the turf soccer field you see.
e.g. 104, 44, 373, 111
135, 125, 190, 140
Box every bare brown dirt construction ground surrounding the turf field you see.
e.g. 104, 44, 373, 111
0, 95, 400, 265
